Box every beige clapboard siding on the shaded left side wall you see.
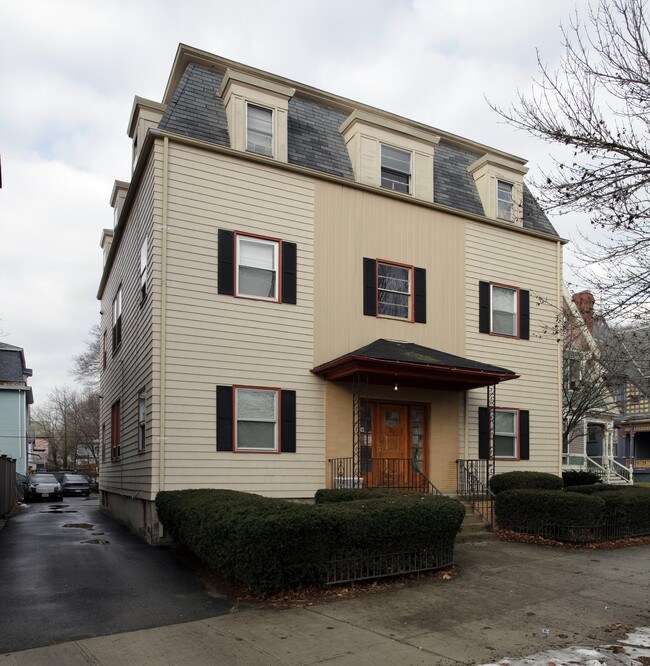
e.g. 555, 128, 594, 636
100, 148, 156, 497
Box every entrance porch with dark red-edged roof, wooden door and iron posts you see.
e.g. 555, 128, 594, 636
312, 340, 518, 525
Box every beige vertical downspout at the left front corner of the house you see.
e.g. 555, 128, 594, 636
158, 137, 169, 538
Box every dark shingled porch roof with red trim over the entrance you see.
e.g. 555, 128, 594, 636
312, 339, 519, 391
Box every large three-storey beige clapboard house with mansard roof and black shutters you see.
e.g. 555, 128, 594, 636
98, 45, 564, 541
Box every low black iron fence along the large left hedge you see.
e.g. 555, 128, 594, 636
326, 543, 454, 585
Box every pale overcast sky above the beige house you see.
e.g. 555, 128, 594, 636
0, 0, 586, 404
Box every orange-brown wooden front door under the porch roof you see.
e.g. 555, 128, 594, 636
375, 403, 411, 487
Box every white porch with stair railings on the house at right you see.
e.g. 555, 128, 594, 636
562, 416, 633, 484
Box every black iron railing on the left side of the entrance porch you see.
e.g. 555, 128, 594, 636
329, 458, 442, 495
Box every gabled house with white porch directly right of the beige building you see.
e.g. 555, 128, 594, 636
562, 288, 633, 483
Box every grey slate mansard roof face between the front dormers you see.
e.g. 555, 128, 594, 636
159, 63, 558, 236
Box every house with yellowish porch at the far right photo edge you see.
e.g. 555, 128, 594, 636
574, 292, 650, 481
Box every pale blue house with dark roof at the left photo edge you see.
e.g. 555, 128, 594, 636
0, 342, 34, 476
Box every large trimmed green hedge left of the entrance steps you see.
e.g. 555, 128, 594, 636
156, 489, 465, 594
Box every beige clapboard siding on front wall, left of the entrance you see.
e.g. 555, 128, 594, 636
155, 143, 324, 497
